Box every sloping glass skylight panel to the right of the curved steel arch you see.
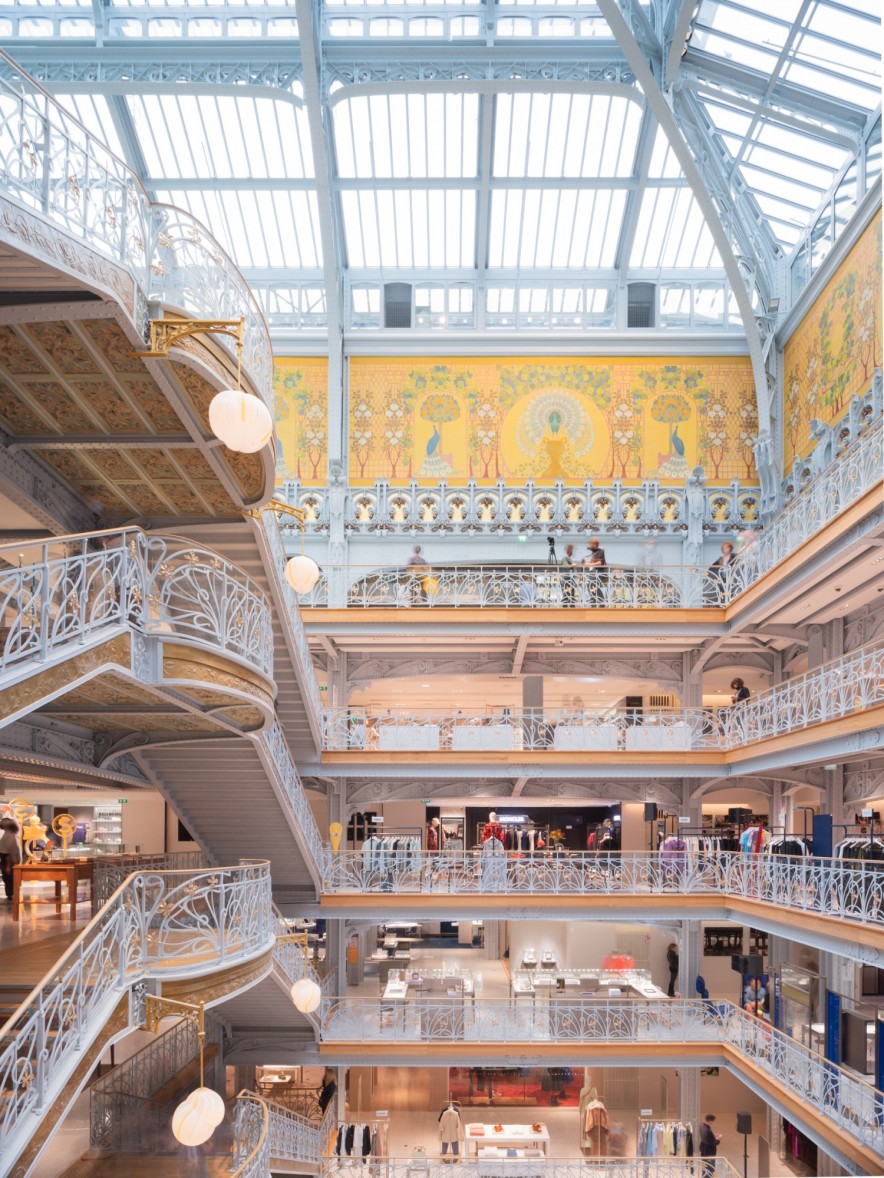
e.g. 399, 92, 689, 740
697, 0, 880, 246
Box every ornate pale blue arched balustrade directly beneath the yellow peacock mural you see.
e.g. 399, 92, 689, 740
281, 478, 760, 536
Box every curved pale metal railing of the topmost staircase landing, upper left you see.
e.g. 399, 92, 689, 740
0, 53, 273, 400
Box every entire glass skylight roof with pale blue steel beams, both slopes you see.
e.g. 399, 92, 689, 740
24, 0, 880, 326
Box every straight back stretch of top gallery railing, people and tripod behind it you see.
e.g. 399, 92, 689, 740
299, 564, 726, 609
